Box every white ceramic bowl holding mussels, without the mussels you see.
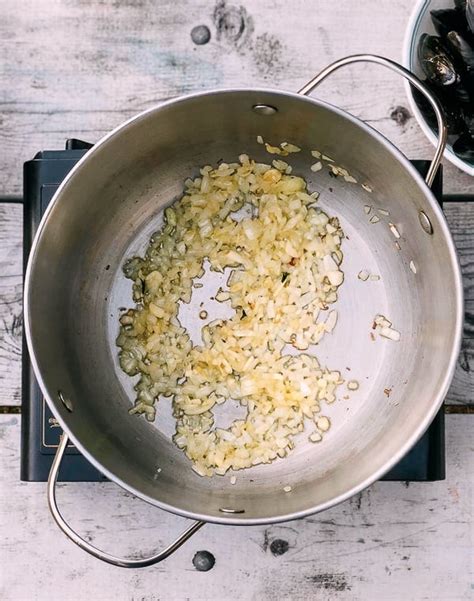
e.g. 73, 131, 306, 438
403, 0, 474, 176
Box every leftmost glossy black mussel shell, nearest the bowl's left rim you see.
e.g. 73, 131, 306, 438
418, 33, 459, 86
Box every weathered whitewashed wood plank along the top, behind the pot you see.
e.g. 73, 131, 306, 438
0, 0, 472, 194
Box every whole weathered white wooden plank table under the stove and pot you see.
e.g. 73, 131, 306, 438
0, 0, 474, 601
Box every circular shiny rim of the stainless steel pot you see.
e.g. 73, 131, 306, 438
23, 88, 463, 526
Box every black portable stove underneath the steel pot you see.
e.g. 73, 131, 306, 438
21, 140, 445, 482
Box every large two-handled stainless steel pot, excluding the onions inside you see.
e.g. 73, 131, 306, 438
25, 55, 462, 567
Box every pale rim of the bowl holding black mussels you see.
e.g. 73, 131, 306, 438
402, 0, 474, 177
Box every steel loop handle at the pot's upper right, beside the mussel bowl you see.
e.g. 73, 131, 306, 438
298, 54, 447, 187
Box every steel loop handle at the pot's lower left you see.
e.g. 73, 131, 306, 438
48, 433, 205, 568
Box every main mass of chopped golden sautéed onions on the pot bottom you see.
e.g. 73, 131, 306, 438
117, 155, 350, 476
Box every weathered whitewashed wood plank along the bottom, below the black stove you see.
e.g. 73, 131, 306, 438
0, 416, 474, 601
